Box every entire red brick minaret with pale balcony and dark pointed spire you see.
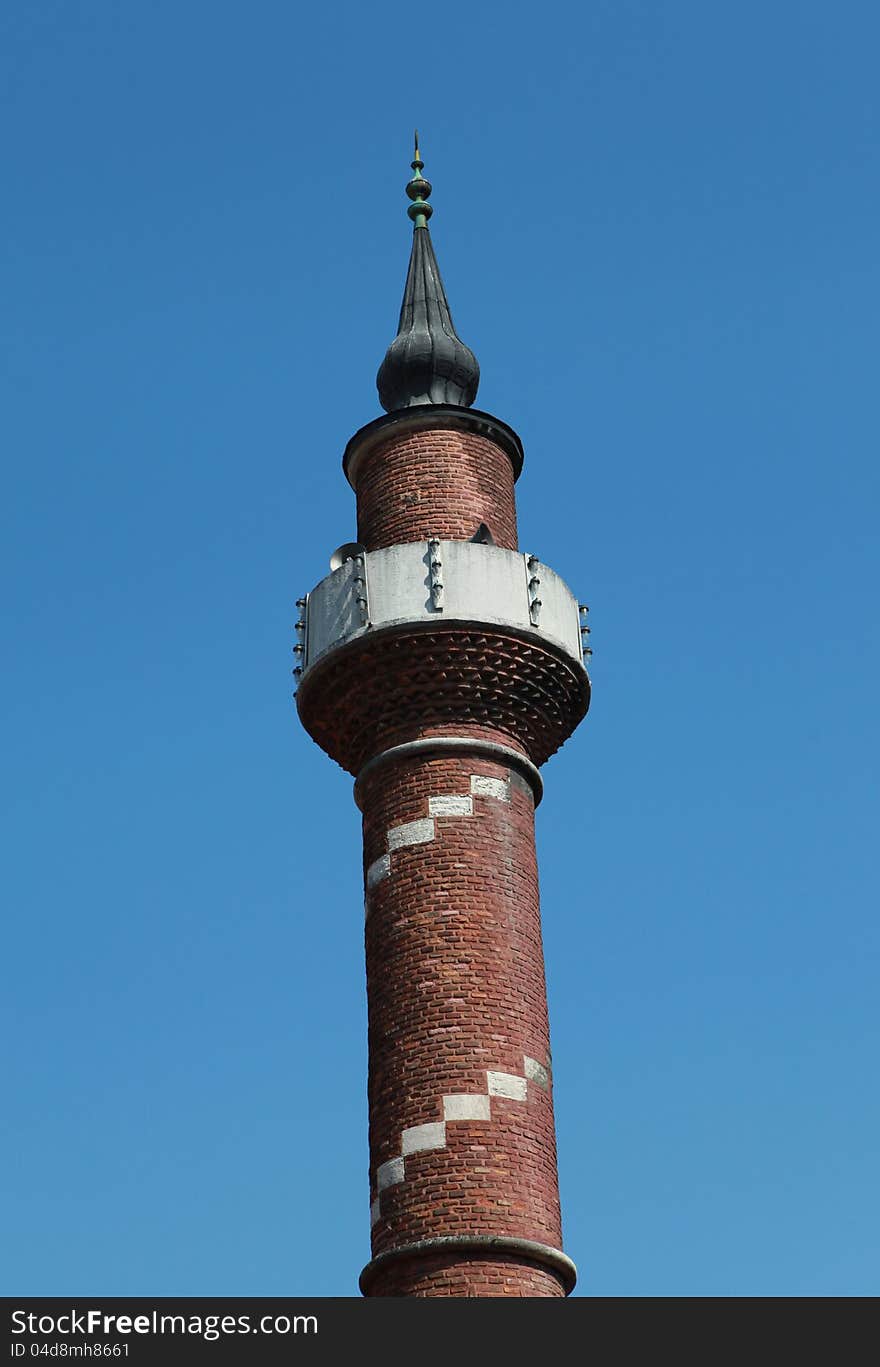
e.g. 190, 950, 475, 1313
295, 142, 590, 1296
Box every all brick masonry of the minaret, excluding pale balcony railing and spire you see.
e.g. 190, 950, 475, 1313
297, 399, 589, 1297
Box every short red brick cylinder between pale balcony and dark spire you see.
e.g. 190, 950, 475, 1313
357, 429, 517, 551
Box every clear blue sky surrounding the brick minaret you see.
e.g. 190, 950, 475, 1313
0, 0, 880, 1296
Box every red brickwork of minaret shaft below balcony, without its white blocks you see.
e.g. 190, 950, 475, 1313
361, 756, 562, 1296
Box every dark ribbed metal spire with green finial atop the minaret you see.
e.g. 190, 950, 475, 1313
376, 133, 480, 413
